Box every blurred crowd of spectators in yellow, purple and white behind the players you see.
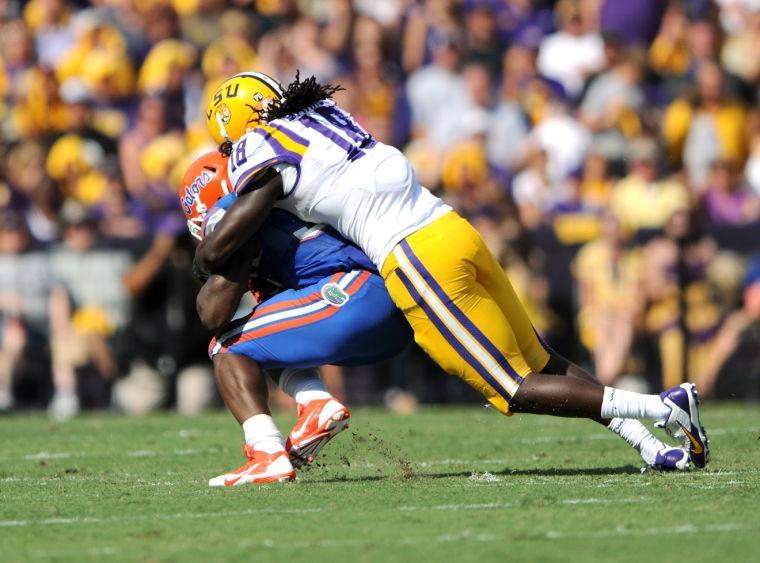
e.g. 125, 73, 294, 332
0, 0, 760, 417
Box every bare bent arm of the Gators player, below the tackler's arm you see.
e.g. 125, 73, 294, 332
196, 240, 258, 333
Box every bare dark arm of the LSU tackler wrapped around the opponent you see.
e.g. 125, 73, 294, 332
195, 168, 283, 273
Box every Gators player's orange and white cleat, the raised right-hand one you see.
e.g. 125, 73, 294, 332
285, 399, 351, 469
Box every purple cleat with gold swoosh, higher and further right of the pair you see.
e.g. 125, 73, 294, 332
655, 383, 710, 467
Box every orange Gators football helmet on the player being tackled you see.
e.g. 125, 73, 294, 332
179, 151, 232, 240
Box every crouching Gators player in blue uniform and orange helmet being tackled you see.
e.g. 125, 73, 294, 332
180, 152, 411, 486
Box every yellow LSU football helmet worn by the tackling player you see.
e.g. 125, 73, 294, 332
206, 72, 282, 145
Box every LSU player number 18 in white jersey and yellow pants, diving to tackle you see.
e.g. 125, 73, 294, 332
196, 72, 708, 470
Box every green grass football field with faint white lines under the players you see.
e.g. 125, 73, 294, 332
0, 404, 760, 562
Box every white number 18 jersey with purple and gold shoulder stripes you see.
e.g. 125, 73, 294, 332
228, 100, 451, 268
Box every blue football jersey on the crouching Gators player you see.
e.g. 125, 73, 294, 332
203, 194, 377, 289
